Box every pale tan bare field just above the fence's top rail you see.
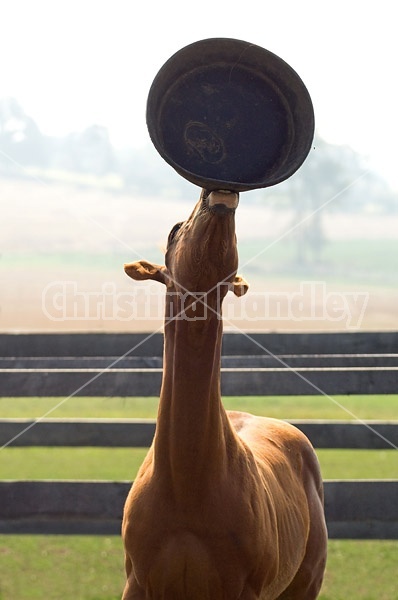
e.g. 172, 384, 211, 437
0, 261, 398, 332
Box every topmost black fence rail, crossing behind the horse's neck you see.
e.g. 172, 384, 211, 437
0, 331, 398, 358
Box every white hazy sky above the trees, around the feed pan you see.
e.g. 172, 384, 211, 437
0, 0, 398, 189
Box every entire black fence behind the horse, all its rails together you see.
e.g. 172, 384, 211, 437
0, 332, 398, 539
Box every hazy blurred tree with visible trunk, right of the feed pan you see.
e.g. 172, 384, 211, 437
281, 137, 398, 266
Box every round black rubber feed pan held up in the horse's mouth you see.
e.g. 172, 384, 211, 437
147, 38, 314, 191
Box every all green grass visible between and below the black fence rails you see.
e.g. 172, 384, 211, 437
0, 396, 398, 600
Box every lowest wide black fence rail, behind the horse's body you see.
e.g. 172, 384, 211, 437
0, 480, 398, 539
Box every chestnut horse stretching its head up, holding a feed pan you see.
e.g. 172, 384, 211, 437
122, 190, 327, 600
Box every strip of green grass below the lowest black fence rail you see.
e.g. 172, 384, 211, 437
0, 536, 398, 600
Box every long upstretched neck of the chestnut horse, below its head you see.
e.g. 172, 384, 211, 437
155, 314, 234, 498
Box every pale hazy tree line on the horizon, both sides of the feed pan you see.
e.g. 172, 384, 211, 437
0, 98, 398, 214
